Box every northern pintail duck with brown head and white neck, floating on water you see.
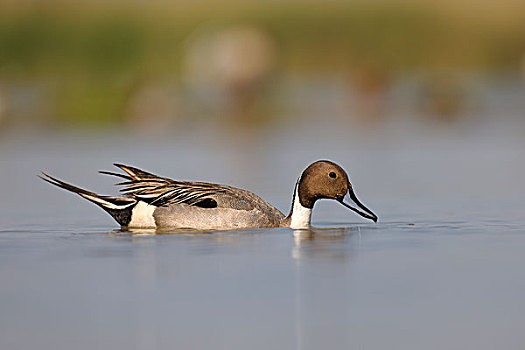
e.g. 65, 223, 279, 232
40, 160, 377, 230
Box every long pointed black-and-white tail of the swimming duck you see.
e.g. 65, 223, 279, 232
37, 172, 137, 226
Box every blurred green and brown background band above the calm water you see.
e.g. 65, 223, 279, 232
0, 0, 525, 136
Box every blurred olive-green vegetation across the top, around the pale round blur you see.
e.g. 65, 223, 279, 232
0, 1, 525, 123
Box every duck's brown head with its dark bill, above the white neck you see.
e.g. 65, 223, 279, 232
297, 160, 377, 222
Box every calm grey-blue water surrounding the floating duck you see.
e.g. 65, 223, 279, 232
0, 126, 525, 349
